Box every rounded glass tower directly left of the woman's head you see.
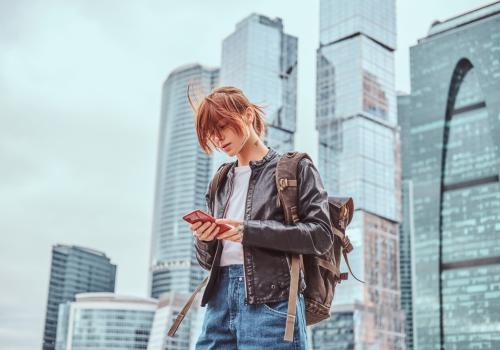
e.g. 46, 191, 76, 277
150, 64, 219, 298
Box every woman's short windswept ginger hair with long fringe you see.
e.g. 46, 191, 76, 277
187, 84, 266, 154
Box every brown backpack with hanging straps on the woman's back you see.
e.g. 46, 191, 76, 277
168, 152, 364, 342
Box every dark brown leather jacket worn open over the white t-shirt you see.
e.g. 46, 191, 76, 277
195, 148, 333, 306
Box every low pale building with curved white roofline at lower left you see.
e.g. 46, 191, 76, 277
56, 293, 158, 350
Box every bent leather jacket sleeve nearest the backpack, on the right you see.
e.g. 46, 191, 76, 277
242, 158, 333, 255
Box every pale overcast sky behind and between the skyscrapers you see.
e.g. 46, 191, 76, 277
0, 0, 491, 350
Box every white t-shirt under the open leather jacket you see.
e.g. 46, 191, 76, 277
220, 165, 252, 266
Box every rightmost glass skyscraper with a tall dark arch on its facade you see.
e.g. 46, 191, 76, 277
402, 1, 500, 350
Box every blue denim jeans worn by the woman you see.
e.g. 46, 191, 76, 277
196, 265, 307, 350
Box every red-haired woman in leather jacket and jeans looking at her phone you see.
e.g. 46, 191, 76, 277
189, 87, 332, 350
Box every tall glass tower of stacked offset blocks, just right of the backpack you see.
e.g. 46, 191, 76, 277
312, 0, 404, 350
